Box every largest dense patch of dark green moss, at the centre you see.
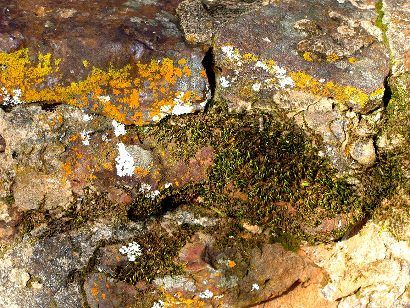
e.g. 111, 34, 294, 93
141, 109, 372, 245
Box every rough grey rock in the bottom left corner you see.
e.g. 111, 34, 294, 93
0, 223, 143, 307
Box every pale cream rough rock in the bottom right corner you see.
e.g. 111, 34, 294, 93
307, 222, 410, 307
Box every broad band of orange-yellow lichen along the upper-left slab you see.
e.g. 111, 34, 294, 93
0, 49, 206, 125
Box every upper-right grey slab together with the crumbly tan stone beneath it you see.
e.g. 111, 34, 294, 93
210, 1, 389, 172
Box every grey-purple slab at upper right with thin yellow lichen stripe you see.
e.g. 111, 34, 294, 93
214, 0, 389, 113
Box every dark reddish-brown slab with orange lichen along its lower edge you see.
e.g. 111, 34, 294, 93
0, 0, 209, 125
